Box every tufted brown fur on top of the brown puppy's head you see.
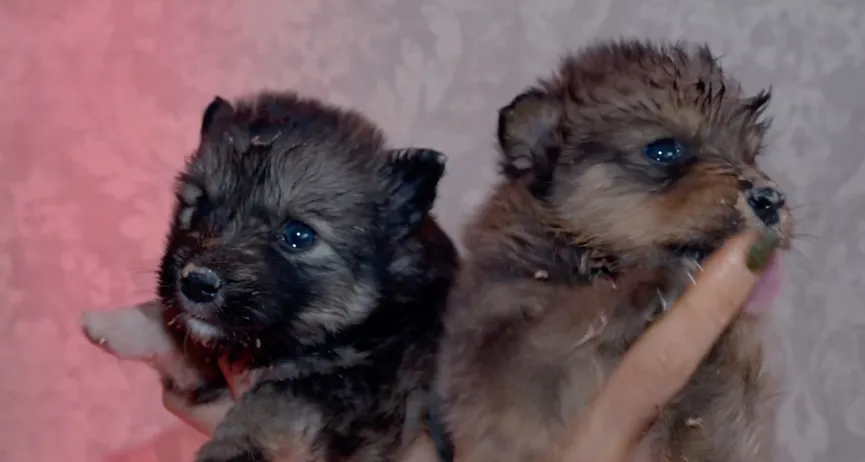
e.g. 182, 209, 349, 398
543, 42, 742, 136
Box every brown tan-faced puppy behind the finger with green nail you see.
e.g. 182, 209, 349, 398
438, 40, 793, 462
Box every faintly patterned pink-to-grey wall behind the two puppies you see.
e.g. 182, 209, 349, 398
0, 0, 865, 462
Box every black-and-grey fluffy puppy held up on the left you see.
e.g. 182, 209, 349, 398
159, 93, 457, 462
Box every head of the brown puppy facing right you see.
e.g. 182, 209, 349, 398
498, 41, 793, 263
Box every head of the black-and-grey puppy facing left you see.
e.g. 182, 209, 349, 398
159, 93, 444, 346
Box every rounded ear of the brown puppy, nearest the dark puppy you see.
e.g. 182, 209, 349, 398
498, 90, 562, 181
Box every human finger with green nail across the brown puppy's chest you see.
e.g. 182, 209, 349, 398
549, 233, 779, 462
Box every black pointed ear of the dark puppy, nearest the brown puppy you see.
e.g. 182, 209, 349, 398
385, 148, 447, 239
